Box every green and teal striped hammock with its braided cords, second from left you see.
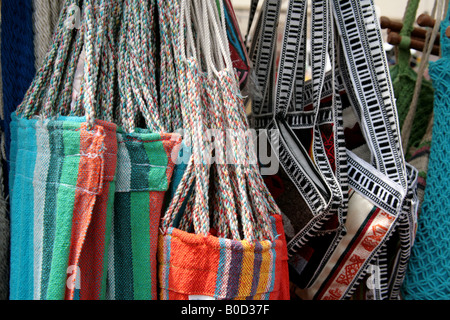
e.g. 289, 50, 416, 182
106, 1, 181, 300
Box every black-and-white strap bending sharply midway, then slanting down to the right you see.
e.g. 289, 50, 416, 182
268, 1, 333, 220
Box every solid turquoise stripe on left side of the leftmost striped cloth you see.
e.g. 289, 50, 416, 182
10, 115, 37, 300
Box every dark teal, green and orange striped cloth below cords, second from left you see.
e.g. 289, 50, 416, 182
106, 130, 181, 300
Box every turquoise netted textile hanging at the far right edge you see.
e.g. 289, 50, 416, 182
403, 5, 450, 300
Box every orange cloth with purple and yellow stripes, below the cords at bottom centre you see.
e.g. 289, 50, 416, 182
158, 220, 286, 300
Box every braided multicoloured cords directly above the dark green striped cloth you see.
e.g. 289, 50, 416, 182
118, 0, 167, 132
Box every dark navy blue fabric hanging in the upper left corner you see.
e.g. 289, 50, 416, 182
1, 0, 35, 190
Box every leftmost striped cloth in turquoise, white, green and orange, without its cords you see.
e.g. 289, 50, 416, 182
10, 115, 117, 300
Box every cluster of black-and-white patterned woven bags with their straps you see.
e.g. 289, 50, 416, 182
246, 0, 417, 299
